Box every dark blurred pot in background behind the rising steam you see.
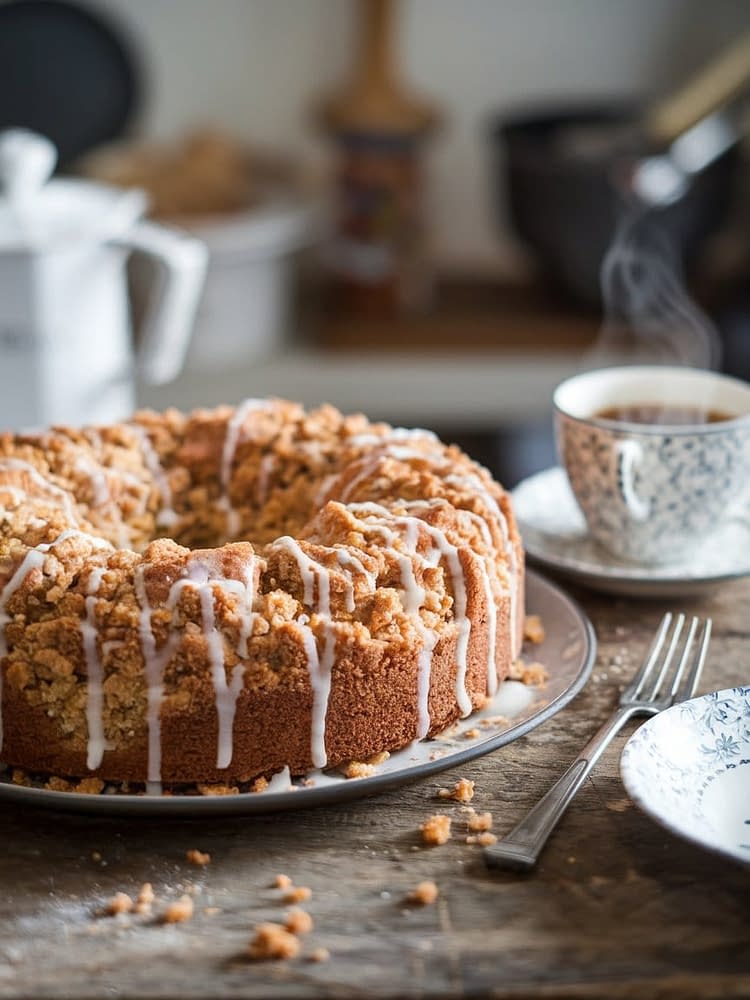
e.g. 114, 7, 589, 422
490, 104, 739, 305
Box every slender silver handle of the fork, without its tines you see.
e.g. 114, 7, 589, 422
484, 707, 638, 871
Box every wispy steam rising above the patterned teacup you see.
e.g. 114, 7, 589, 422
586, 211, 721, 369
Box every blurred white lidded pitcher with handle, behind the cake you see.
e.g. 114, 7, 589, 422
0, 129, 207, 429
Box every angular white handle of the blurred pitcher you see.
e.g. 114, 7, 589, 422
117, 222, 208, 385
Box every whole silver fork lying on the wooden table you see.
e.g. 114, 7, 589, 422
484, 613, 711, 871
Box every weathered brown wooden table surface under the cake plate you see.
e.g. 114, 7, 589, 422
0, 583, 750, 1000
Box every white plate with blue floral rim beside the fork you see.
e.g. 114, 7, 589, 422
620, 687, 750, 865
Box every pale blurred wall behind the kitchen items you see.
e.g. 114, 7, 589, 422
89, 0, 750, 271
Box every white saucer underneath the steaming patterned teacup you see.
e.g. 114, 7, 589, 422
511, 466, 750, 598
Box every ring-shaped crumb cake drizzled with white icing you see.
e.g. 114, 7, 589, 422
0, 400, 523, 788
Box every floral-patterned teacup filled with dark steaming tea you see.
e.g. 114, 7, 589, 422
553, 365, 750, 563
